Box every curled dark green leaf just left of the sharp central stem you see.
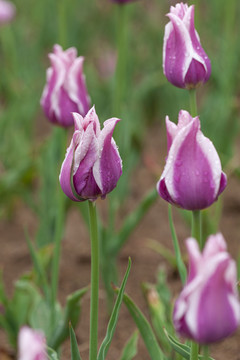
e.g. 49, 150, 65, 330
49, 287, 88, 349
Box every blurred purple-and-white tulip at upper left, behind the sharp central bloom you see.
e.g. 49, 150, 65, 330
41, 45, 90, 127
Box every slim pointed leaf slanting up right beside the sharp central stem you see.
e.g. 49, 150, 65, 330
97, 258, 131, 360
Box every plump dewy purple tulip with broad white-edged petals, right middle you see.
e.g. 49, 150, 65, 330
157, 110, 227, 210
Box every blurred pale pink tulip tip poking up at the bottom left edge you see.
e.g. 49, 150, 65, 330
18, 326, 48, 360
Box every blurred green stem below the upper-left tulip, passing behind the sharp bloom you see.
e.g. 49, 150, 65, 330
52, 128, 67, 306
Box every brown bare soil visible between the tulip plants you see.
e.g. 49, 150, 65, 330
0, 126, 240, 360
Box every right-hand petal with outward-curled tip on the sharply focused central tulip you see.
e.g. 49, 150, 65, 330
93, 118, 122, 196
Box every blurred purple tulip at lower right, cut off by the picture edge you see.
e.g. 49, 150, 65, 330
173, 234, 240, 344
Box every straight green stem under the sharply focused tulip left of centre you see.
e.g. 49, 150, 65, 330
88, 201, 99, 360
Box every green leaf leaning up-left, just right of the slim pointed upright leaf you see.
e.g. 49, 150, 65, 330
118, 294, 165, 360
